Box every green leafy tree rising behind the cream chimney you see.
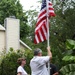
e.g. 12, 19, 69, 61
0, 0, 29, 38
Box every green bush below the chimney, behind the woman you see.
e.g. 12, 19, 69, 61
0, 49, 33, 75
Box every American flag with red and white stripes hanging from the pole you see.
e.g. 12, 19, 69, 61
34, 0, 55, 44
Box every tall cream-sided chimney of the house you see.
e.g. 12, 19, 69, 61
5, 18, 20, 52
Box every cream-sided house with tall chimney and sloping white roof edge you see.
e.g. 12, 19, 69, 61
0, 18, 31, 52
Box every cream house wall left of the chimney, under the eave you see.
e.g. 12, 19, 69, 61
0, 30, 5, 52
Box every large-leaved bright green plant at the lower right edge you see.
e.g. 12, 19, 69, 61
60, 39, 75, 75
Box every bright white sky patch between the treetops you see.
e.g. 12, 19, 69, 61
20, 0, 39, 10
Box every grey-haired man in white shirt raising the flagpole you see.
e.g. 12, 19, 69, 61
30, 47, 52, 75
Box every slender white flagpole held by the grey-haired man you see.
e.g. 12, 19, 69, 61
46, 0, 50, 75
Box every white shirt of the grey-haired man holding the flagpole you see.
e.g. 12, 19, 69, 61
30, 56, 50, 75
